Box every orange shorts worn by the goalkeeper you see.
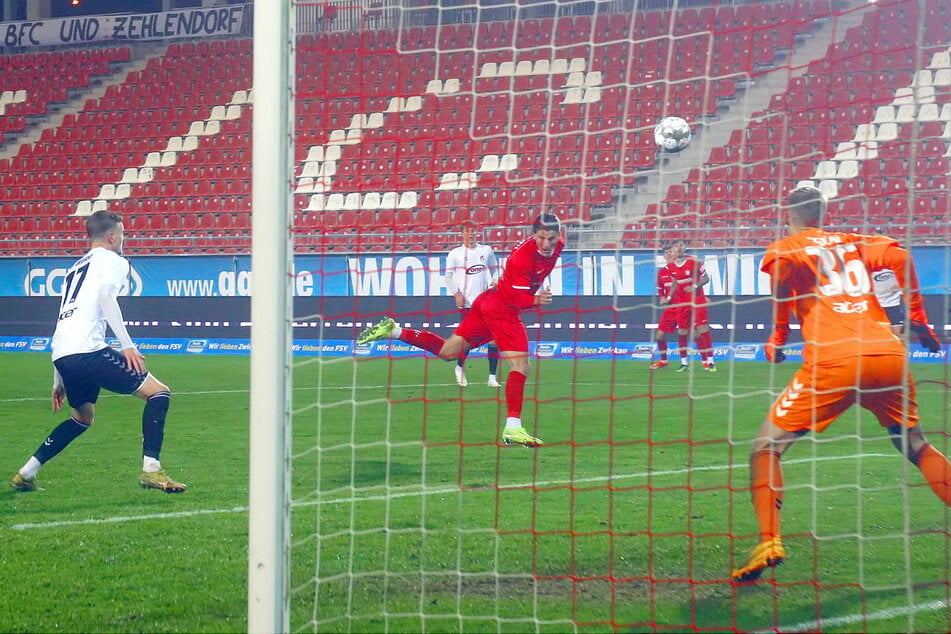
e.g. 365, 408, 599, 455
767, 355, 919, 432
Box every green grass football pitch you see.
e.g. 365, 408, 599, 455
0, 353, 951, 632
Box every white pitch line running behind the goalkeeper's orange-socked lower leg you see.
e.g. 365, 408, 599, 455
8, 453, 899, 531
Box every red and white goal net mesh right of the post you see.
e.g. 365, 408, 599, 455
287, 0, 951, 632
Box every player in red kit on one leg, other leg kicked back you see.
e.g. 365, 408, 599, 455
357, 213, 565, 447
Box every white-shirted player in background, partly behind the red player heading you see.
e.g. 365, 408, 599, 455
446, 223, 501, 387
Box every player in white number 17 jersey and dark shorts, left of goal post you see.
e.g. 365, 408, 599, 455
10, 211, 187, 493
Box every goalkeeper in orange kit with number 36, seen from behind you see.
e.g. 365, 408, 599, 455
732, 187, 951, 583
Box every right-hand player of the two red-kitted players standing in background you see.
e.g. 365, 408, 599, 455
665, 239, 717, 372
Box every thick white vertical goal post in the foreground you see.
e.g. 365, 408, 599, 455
248, 0, 295, 634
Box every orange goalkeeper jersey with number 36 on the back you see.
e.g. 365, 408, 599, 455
761, 228, 921, 363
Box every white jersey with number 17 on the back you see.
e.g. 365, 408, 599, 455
52, 247, 129, 361
